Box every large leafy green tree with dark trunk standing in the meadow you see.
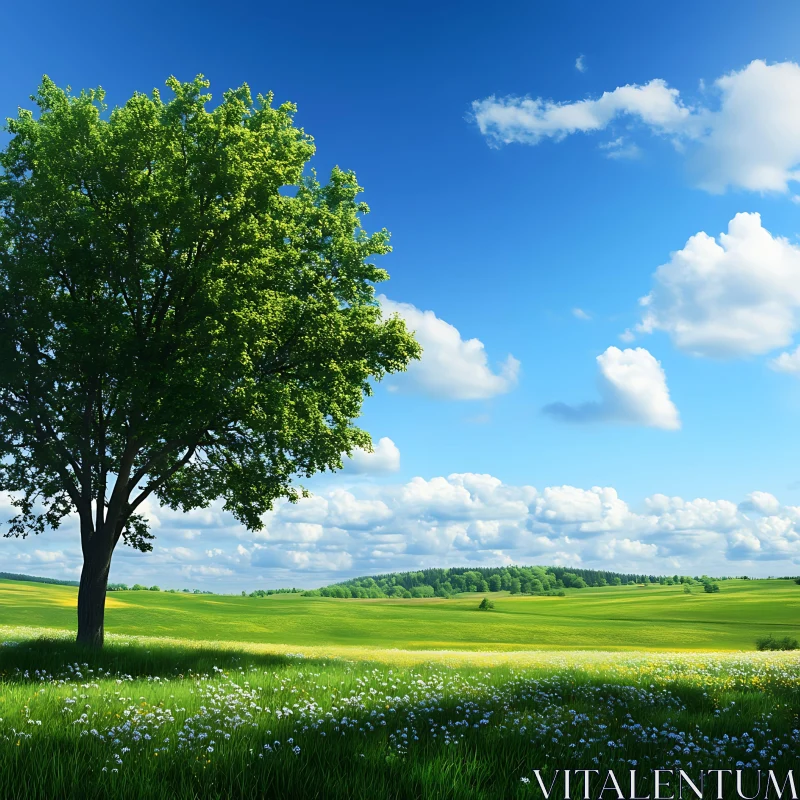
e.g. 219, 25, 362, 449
0, 76, 420, 646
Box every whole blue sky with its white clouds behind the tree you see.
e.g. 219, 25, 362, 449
0, 2, 800, 589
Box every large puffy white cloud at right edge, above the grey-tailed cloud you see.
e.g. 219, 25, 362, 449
637, 213, 800, 360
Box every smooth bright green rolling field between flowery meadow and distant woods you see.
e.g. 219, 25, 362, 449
0, 580, 800, 650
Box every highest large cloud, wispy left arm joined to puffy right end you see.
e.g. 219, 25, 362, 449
472, 60, 800, 192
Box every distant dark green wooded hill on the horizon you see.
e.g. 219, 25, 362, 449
304, 567, 736, 598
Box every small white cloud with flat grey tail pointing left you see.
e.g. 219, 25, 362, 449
544, 347, 681, 430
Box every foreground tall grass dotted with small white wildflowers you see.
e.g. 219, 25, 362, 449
0, 632, 800, 800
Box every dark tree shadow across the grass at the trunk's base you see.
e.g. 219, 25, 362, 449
0, 637, 329, 683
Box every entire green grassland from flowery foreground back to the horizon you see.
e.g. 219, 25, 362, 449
0, 581, 800, 800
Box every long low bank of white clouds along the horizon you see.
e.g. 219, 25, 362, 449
0, 473, 800, 592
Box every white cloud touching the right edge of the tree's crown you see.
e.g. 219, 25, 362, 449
380, 296, 520, 400
